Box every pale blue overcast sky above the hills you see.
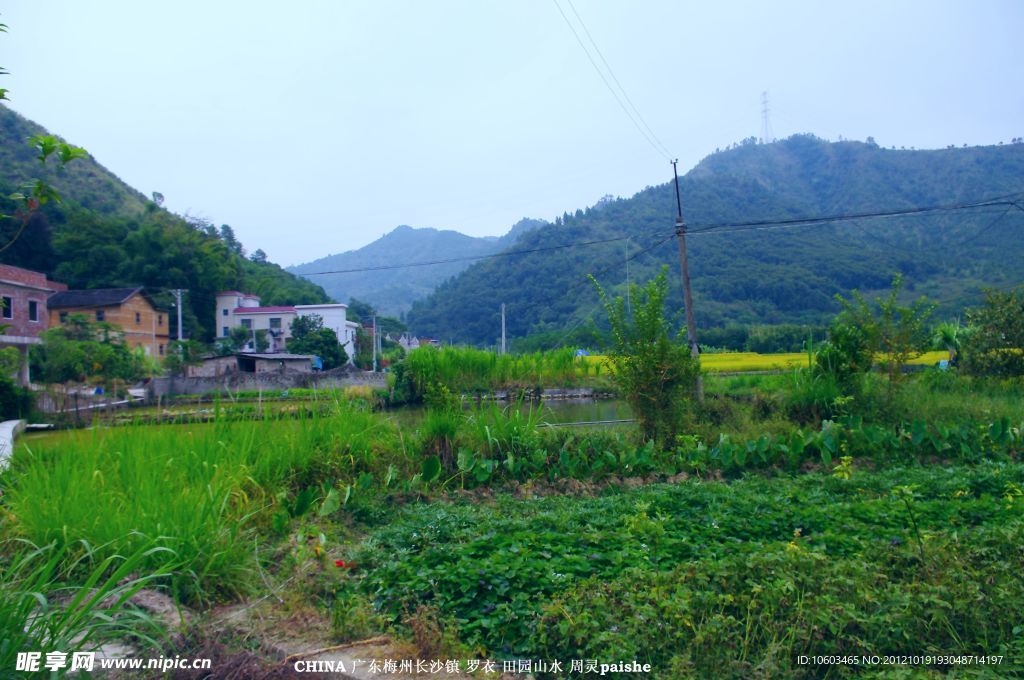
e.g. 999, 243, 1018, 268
0, 0, 1024, 265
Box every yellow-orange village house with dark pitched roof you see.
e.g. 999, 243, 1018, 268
46, 288, 170, 357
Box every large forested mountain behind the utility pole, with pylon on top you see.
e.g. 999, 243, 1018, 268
408, 135, 1024, 344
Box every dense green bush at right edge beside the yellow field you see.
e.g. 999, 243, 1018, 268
964, 289, 1024, 376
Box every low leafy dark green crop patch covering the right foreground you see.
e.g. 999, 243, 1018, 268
352, 464, 1024, 663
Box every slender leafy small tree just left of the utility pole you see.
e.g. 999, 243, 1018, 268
591, 267, 700, 447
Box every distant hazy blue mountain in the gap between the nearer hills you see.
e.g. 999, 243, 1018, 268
288, 219, 546, 316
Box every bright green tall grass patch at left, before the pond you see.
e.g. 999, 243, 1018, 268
5, 402, 410, 600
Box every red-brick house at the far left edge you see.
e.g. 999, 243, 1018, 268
0, 264, 68, 386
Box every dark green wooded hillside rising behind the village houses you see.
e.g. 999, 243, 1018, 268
0, 105, 330, 340
